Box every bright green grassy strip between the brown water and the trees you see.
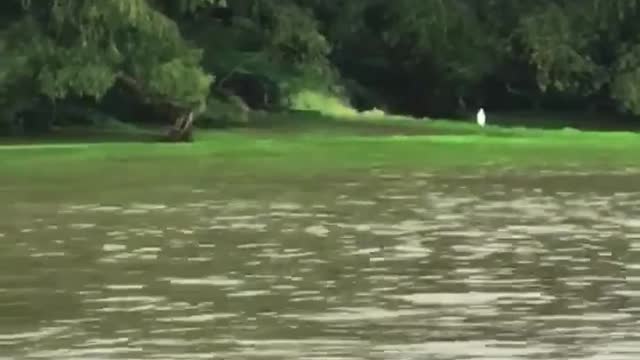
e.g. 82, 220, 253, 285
0, 113, 640, 193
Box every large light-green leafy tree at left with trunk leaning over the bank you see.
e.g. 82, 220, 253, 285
0, 0, 213, 136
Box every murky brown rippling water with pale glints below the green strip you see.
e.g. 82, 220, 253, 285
0, 174, 640, 360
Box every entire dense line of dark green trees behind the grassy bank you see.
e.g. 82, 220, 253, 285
0, 0, 640, 136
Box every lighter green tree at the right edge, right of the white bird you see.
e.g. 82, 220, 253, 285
519, 0, 640, 114
